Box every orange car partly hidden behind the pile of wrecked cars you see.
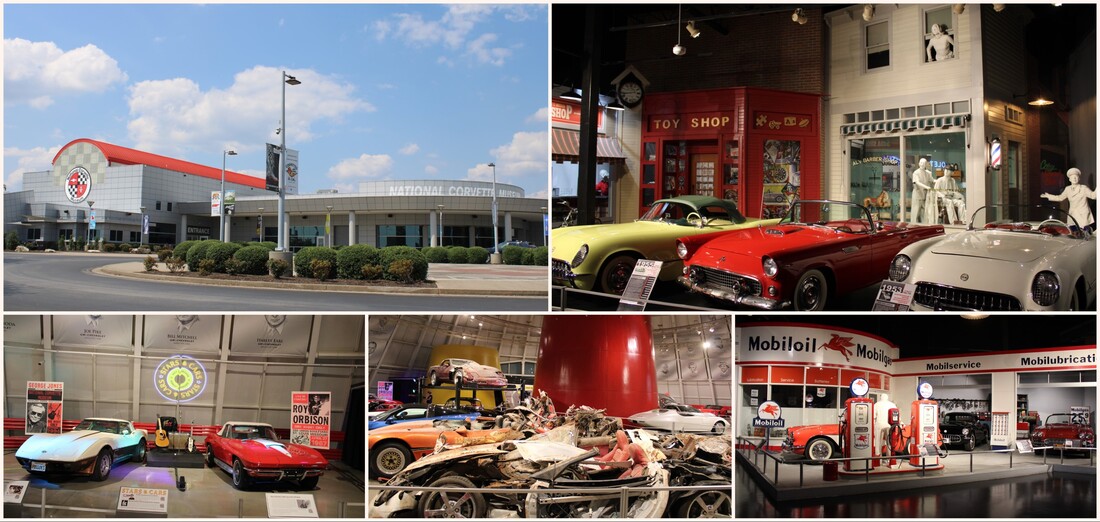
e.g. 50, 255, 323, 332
366, 418, 515, 479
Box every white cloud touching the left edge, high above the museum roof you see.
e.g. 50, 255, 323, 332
3, 38, 128, 109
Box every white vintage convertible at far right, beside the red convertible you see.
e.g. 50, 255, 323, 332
889, 206, 1097, 311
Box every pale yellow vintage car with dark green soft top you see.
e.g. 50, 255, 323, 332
550, 196, 779, 293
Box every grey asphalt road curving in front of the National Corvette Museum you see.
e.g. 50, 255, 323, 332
3, 252, 548, 313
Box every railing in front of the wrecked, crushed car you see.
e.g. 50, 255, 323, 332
370, 484, 734, 518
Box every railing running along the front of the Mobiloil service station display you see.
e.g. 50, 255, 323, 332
735, 436, 1097, 487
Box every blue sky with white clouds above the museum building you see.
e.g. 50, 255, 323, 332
3, 3, 550, 197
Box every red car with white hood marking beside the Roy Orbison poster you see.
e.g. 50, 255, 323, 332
206, 421, 329, 490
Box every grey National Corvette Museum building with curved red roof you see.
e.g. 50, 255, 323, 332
4, 138, 547, 251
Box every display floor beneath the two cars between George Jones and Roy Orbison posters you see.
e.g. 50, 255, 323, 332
3, 452, 366, 519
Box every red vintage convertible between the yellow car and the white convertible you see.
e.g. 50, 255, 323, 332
677, 200, 944, 310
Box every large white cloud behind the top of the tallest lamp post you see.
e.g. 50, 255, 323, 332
128, 66, 375, 157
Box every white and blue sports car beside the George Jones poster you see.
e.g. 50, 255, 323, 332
15, 418, 145, 480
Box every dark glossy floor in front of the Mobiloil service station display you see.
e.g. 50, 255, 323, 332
734, 451, 1097, 519
